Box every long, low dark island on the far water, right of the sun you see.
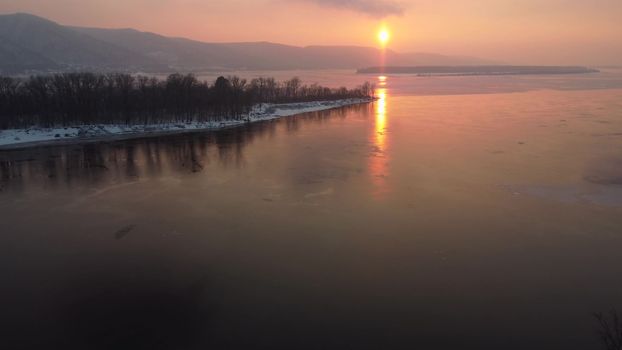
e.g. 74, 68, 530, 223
357, 66, 600, 76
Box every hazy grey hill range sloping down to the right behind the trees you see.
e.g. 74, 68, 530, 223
0, 14, 496, 73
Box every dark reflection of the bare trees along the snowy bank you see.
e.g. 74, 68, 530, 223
0, 105, 368, 191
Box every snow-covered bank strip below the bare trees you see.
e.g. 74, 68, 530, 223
0, 98, 372, 149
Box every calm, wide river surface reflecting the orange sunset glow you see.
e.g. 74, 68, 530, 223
0, 70, 622, 349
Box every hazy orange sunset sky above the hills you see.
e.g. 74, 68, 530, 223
0, 0, 622, 65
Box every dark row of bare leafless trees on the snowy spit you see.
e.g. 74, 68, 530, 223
0, 73, 374, 129
